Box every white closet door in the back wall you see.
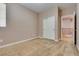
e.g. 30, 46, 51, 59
43, 16, 55, 40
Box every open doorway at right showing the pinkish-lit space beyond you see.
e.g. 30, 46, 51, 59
61, 15, 75, 42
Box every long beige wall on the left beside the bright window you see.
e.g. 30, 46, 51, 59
0, 4, 37, 45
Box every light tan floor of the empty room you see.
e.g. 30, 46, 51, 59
0, 38, 79, 56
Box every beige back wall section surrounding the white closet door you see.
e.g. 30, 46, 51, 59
38, 6, 58, 39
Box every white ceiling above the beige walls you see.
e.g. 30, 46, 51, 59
21, 3, 76, 13
